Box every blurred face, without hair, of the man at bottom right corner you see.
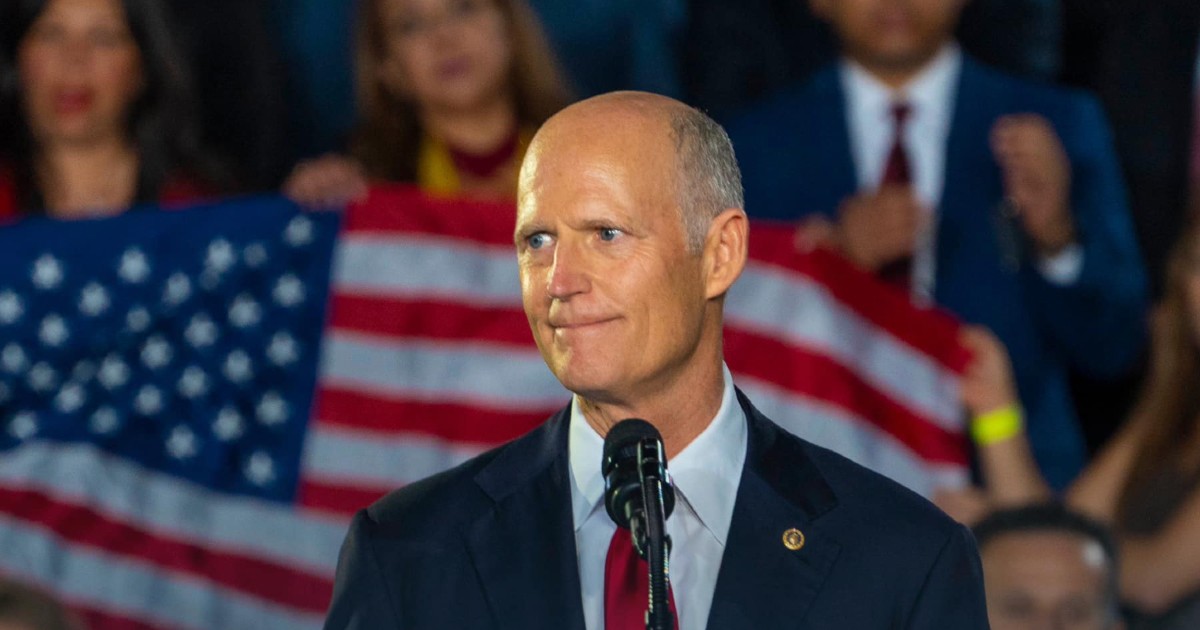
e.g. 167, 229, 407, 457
982, 532, 1120, 630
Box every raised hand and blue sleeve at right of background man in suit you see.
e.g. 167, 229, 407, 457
992, 96, 1147, 378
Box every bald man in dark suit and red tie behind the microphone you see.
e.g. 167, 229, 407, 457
326, 92, 986, 630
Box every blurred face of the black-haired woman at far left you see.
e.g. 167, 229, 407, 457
17, 0, 143, 144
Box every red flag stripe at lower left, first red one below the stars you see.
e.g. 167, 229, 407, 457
0, 487, 334, 612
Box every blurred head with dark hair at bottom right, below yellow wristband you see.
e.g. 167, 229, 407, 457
974, 505, 1123, 630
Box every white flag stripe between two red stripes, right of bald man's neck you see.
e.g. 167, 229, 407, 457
725, 263, 962, 432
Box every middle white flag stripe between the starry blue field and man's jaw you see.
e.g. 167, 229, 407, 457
320, 330, 570, 413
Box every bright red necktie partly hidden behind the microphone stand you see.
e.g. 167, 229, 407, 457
604, 527, 679, 630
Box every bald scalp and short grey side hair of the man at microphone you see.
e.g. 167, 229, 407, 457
517, 91, 744, 253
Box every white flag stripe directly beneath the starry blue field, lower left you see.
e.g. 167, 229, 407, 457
0, 442, 346, 576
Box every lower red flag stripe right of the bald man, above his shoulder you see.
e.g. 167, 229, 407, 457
725, 329, 967, 464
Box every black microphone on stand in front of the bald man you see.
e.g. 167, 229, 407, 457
600, 418, 674, 630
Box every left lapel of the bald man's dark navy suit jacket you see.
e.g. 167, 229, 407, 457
467, 408, 583, 630
